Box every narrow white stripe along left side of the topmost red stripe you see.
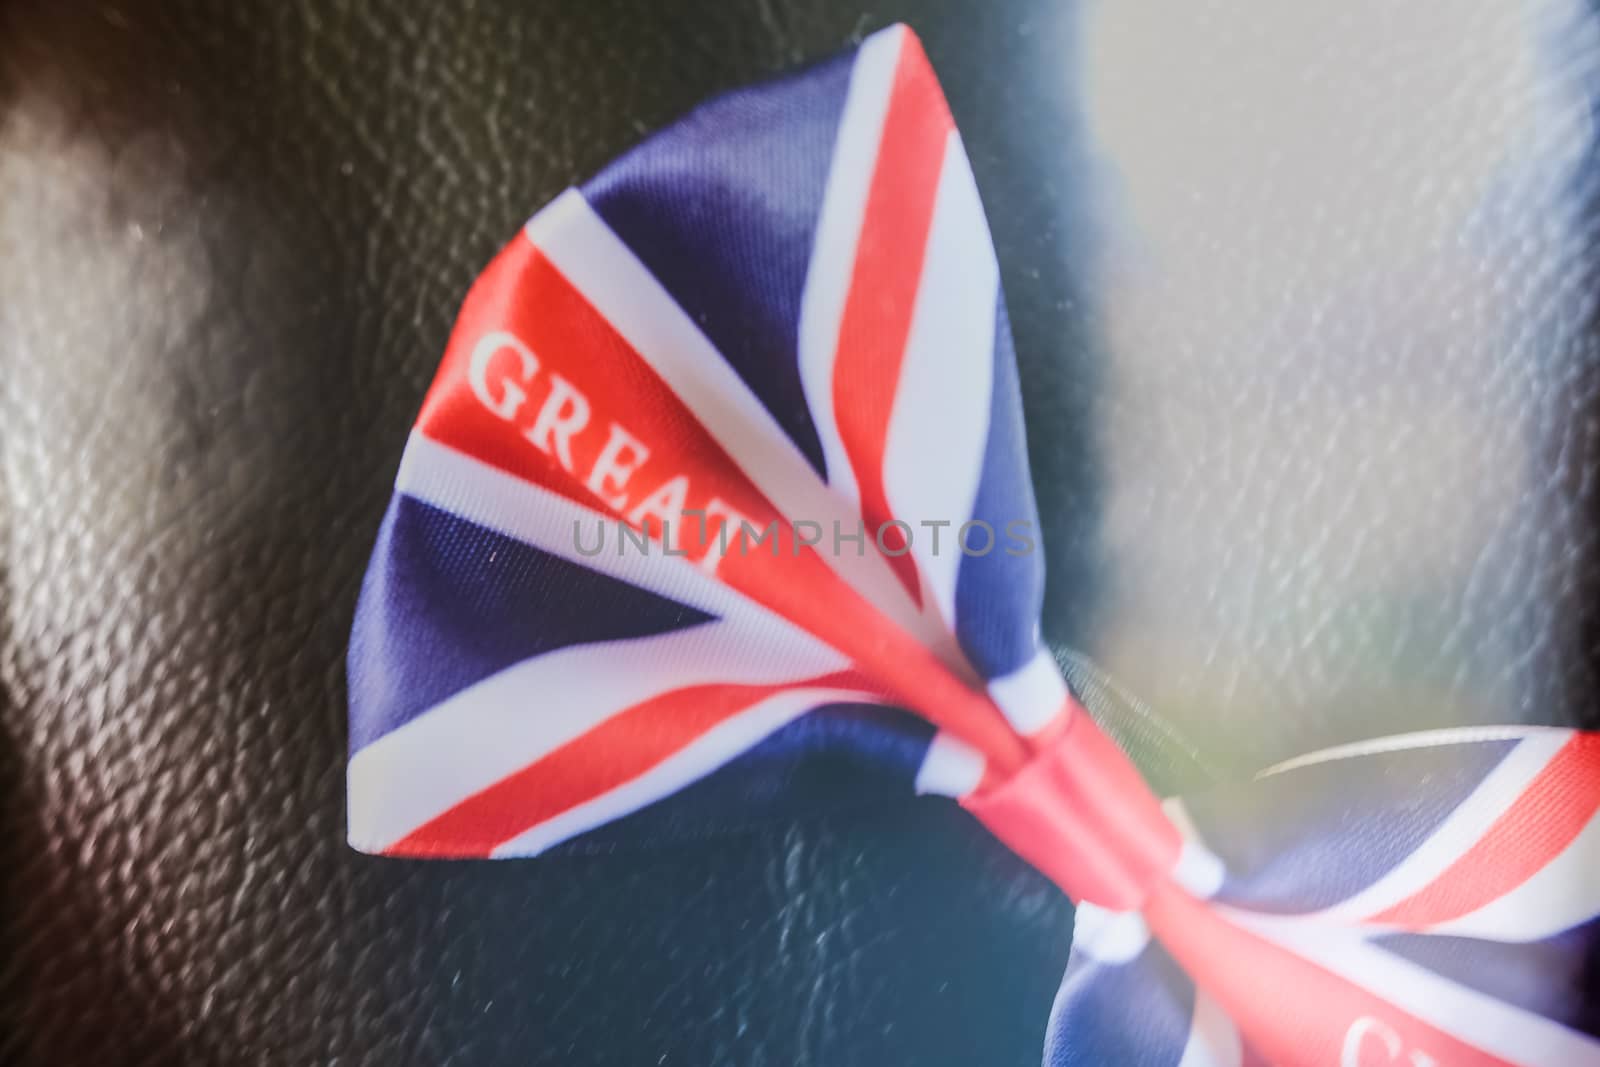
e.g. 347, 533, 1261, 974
800, 26, 906, 524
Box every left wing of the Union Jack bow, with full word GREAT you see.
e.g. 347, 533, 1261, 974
349, 26, 1067, 857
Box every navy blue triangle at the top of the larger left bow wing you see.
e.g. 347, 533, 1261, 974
582, 54, 854, 477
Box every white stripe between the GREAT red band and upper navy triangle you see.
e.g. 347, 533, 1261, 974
525, 189, 938, 645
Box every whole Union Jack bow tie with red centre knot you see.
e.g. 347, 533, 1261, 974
349, 27, 1600, 1067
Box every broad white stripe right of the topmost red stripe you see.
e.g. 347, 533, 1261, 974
883, 131, 992, 633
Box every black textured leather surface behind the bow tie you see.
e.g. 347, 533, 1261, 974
0, 0, 1600, 1067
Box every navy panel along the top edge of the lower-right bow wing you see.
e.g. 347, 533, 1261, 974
1184, 741, 1517, 912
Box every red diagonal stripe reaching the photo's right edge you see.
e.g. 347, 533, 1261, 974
1370, 733, 1600, 929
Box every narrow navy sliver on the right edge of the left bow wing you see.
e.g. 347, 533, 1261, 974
955, 294, 1045, 678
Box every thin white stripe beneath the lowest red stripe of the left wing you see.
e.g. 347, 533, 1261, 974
493, 689, 862, 859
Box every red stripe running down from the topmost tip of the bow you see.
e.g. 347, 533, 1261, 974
834, 34, 955, 605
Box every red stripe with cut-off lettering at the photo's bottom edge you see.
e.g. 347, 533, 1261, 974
1144, 883, 1515, 1067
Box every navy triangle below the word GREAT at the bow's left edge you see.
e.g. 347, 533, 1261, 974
349, 493, 714, 753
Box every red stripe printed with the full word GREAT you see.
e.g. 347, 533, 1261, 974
418, 235, 1024, 768
